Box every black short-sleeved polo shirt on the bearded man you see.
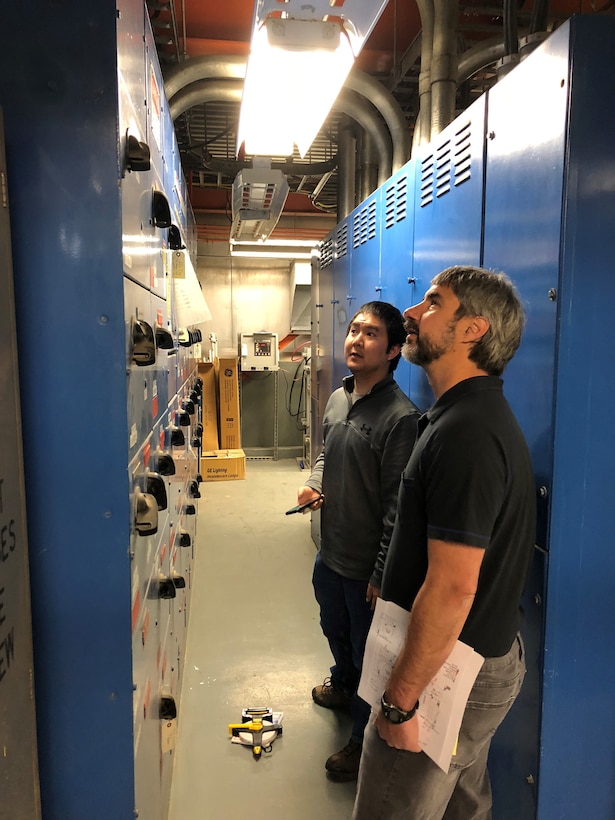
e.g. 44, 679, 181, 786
382, 376, 536, 657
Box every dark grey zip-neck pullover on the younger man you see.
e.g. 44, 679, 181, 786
306, 374, 419, 589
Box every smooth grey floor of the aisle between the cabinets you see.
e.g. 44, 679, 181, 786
169, 460, 355, 820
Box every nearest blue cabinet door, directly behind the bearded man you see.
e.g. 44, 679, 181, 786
484, 38, 568, 820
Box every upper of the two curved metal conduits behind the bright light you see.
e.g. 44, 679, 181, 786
164, 56, 400, 179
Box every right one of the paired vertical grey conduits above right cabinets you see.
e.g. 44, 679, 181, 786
431, 0, 459, 139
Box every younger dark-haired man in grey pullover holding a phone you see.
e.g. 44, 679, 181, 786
297, 302, 419, 781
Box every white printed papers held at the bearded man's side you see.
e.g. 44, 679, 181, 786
358, 598, 484, 772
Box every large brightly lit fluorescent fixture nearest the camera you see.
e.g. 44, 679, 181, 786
237, 0, 388, 157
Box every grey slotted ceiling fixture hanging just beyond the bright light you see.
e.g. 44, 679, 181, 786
231, 163, 288, 241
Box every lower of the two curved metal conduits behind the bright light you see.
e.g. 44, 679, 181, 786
169, 80, 391, 183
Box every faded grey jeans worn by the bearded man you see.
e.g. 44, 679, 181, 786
352, 635, 525, 820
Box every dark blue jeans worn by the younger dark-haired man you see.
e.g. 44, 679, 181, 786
312, 553, 373, 742
